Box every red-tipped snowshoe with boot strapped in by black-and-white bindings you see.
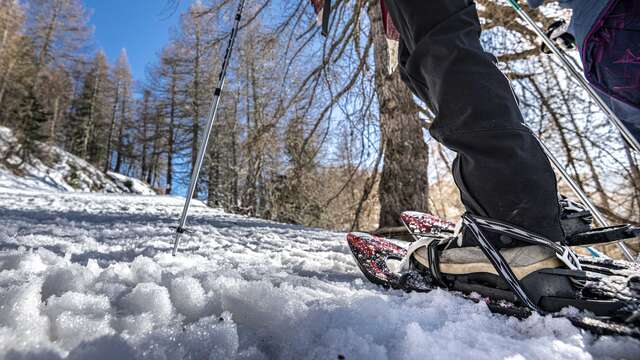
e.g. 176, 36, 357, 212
347, 213, 640, 338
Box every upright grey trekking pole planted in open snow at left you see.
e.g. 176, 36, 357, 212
172, 0, 245, 256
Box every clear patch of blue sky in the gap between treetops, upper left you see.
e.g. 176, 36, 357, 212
83, 0, 191, 80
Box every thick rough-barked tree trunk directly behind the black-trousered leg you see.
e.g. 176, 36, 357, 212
368, 1, 429, 228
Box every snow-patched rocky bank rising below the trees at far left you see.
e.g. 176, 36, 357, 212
0, 126, 156, 195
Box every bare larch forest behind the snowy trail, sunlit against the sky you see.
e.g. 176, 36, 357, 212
0, 0, 640, 245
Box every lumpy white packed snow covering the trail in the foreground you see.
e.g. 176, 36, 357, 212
0, 187, 640, 360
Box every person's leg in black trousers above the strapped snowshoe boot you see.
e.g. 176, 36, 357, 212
385, 0, 564, 246
